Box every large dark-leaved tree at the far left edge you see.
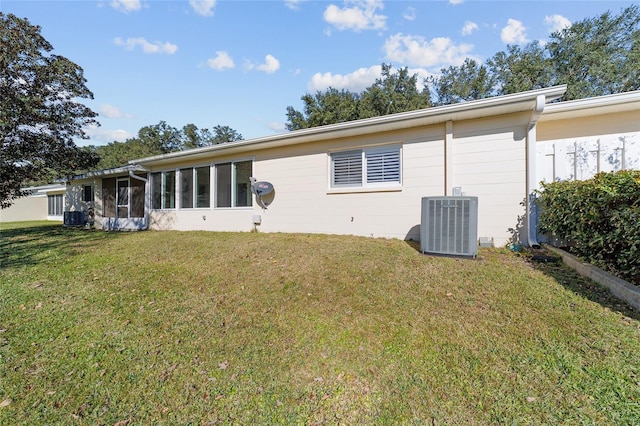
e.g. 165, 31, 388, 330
0, 13, 98, 208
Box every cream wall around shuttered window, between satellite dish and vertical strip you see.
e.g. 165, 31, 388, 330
249, 126, 444, 239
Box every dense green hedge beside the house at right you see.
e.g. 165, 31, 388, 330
538, 170, 640, 285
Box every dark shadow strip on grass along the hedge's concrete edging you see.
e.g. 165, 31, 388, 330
529, 252, 640, 321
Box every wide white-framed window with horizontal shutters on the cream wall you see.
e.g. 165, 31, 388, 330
330, 145, 401, 188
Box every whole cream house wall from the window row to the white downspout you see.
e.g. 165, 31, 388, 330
149, 114, 528, 245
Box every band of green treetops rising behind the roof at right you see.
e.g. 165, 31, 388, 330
286, 5, 640, 130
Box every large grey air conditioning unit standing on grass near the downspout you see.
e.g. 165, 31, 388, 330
420, 197, 478, 257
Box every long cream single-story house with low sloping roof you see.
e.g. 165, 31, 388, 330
66, 86, 640, 246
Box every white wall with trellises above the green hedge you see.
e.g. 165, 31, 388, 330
536, 111, 640, 182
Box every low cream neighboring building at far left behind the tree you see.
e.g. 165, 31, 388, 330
0, 184, 66, 222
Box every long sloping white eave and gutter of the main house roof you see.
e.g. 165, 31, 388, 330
129, 85, 567, 167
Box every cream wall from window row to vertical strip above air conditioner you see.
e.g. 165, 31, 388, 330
150, 126, 444, 239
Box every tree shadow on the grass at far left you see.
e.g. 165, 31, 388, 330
0, 224, 120, 269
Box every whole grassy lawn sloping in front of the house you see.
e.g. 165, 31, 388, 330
0, 224, 640, 426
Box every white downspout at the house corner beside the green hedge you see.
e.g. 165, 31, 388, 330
523, 95, 547, 248
